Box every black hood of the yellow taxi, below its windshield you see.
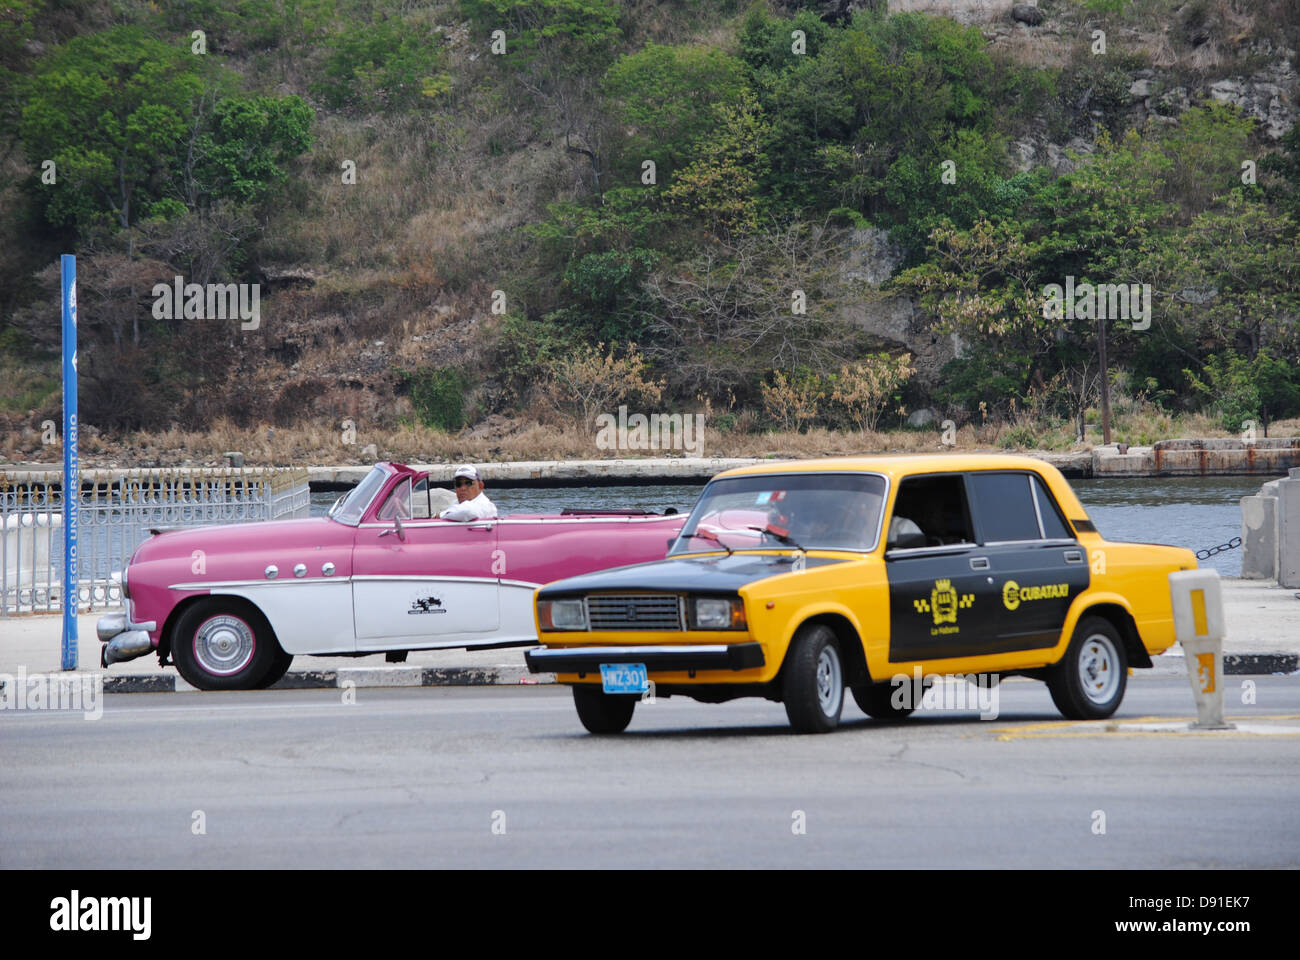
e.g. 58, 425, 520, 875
540, 553, 846, 598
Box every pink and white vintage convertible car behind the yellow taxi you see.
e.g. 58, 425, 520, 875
98, 463, 685, 689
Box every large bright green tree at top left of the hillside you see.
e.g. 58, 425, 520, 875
22, 27, 313, 233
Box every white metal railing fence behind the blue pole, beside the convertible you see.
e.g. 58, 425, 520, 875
0, 467, 311, 617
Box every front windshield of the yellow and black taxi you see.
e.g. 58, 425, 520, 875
670, 473, 885, 555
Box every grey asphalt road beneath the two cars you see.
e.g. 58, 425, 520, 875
0, 674, 1300, 869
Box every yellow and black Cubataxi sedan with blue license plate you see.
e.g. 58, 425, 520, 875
525, 454, 1196, 734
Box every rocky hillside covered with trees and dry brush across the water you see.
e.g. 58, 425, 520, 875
0, 0, 1300, 458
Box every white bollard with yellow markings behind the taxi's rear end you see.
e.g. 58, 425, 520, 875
1169, 570, 1234, 730
